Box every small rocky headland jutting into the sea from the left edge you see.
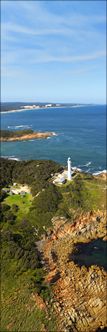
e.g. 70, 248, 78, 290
0, 129, 56, 142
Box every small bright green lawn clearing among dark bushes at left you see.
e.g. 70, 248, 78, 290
4, 193, 33, 221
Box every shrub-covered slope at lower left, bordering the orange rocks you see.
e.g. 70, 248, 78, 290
1, 221, 57, 332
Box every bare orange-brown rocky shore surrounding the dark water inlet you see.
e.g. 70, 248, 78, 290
38, 210, 107, 332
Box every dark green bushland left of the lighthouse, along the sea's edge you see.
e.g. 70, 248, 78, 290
0, 158, 62, 191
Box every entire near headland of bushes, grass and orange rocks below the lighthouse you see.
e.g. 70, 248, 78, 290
0, 158, 107, 332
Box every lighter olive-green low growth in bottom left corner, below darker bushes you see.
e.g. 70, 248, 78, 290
1, 273, 54, 332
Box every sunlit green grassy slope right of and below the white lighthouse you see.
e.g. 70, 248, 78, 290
56, 174, 106, 217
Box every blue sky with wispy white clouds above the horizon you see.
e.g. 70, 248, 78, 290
1, 0, 106, 103
